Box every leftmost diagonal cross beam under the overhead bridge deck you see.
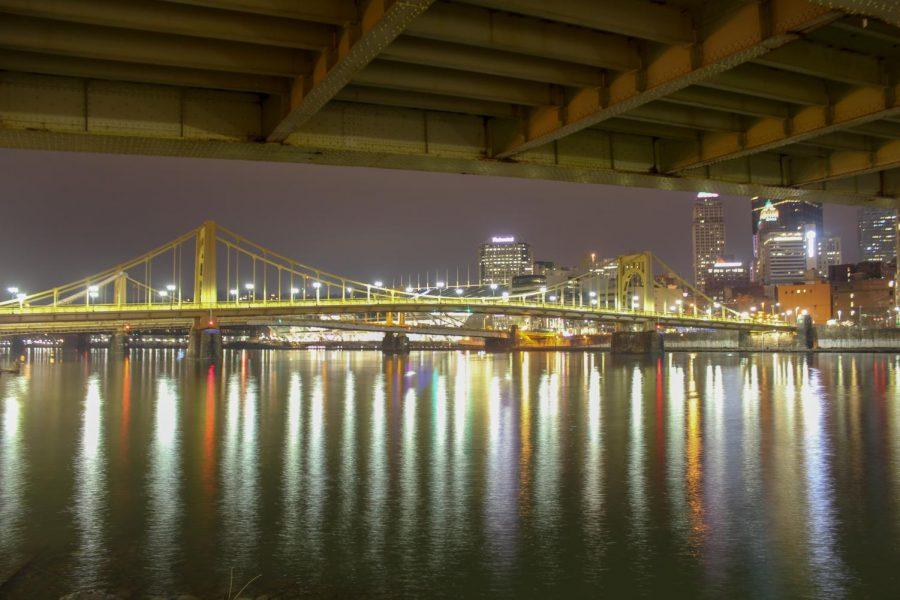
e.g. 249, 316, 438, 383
266, 0, 434, 142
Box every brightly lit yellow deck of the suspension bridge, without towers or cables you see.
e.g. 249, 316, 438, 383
0, 297, 796, 337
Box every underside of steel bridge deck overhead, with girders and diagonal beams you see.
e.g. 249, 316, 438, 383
0, 0, 900, 206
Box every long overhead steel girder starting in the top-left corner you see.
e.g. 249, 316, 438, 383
0, 0, 334, 50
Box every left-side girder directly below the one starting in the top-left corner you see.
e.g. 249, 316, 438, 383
0, 15, 312, 76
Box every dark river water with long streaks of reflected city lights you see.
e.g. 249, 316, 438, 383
0, 350, 900, 598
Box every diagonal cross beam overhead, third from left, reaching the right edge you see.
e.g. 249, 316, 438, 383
662, 82, 900, 172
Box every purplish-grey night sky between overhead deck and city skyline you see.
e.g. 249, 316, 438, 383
0, 150, 858, 291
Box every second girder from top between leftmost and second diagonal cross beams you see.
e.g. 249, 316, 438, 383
405, 2, 641, 71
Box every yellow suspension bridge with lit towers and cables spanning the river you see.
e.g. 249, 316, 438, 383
0, 221, 796, 354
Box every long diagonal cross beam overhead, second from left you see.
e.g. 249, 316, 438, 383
494, 0, 840, 158
